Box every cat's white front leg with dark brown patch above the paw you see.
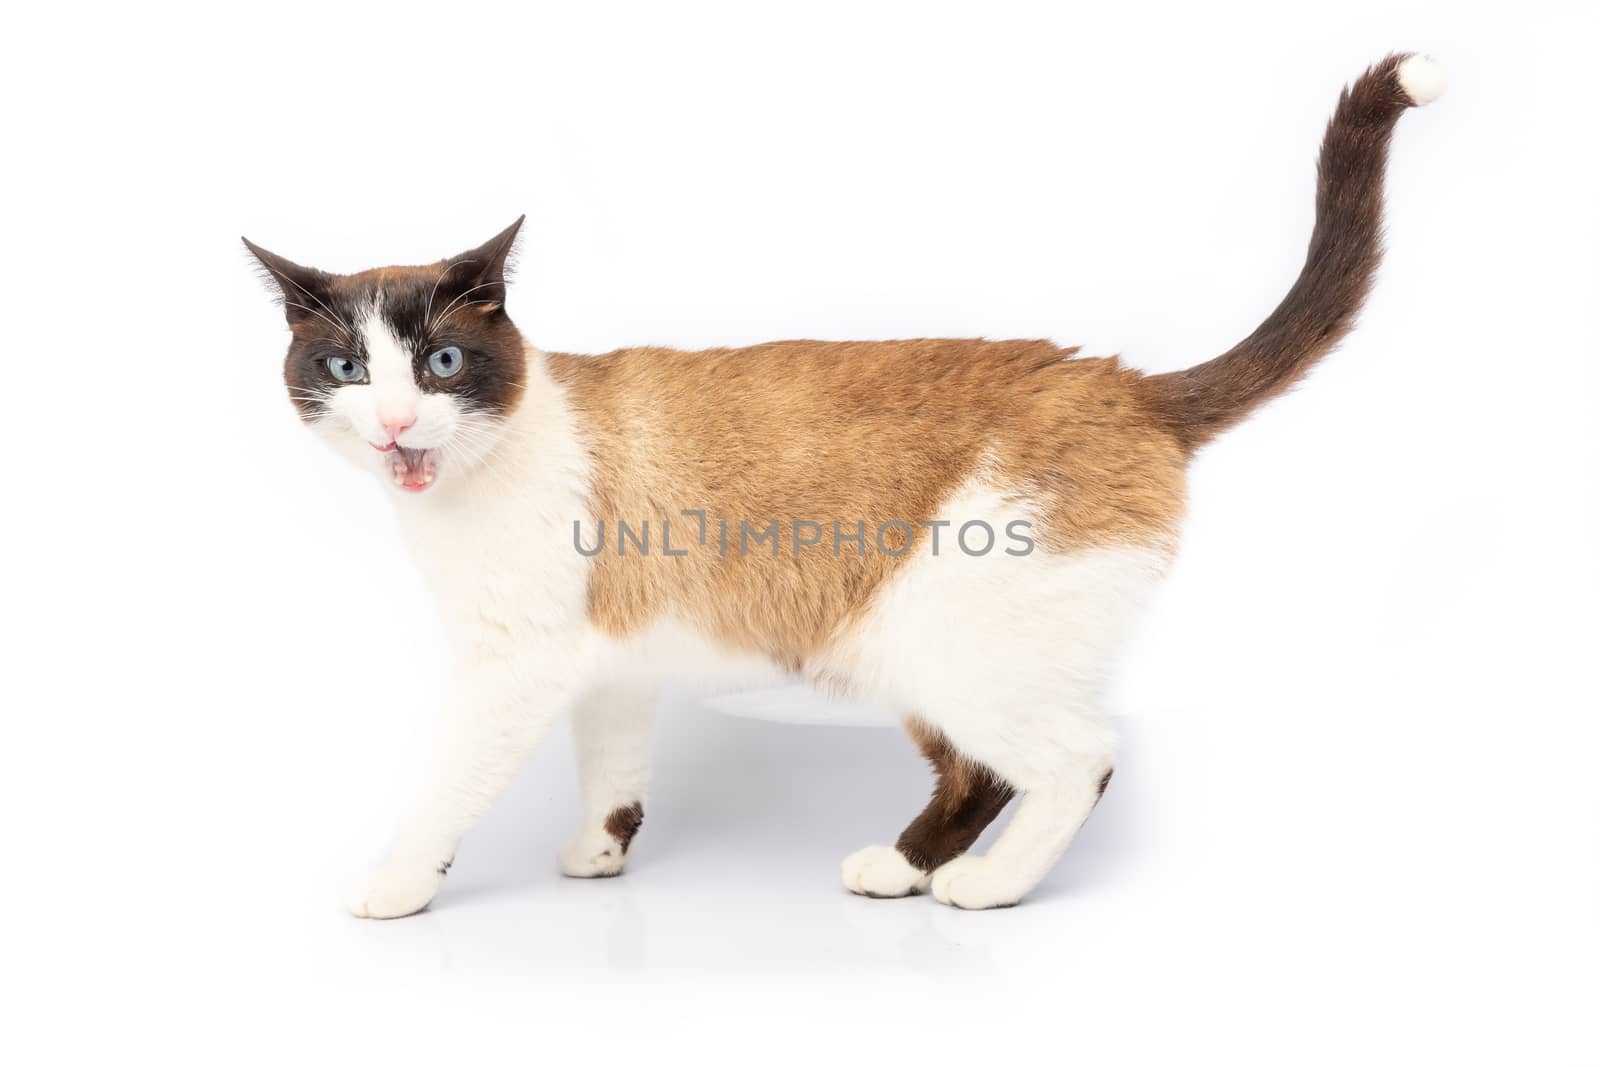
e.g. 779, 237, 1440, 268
558, 686, 656, 878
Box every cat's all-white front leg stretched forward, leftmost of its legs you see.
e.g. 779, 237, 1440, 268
347, 654, 574, 918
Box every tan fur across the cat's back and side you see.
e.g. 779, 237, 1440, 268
550, 341, 1187, 669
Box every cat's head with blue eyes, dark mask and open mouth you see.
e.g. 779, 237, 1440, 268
245, 219, 528, 493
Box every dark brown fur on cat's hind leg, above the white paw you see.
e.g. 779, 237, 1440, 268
894, 718, 1011, 870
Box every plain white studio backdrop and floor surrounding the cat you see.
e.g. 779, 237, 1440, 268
0, 0, 1600, 1064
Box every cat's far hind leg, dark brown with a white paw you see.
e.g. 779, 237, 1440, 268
840, 718, 1011, 897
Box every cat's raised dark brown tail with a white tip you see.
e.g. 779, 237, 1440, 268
1144, 54, 1443, 451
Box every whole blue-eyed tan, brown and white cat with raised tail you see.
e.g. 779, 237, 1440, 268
245, 54, 1443, 918
